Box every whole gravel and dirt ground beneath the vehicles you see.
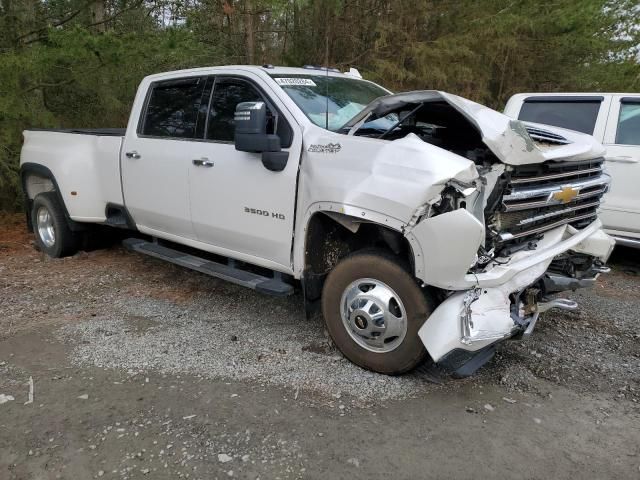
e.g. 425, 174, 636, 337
0, 217, 640, 478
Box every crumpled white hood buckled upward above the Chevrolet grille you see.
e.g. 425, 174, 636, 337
349, 90, 605, 165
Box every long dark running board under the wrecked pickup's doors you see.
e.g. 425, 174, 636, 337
122, 238, 293, 297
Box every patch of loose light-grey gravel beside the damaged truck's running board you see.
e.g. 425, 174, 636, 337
56, 288, 436, 402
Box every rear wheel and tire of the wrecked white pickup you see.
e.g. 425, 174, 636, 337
31, 192, 80, 258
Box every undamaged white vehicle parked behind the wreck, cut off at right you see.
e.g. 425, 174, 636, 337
504, 93, 640, 248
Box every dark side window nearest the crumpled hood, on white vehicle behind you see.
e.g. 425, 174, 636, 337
518, 95, 604, 135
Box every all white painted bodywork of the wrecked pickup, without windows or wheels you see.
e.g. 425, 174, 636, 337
21, 66, 612, 368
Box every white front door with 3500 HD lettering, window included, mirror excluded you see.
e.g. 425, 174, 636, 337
189, 76, 302, 271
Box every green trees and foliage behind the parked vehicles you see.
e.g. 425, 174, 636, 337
0, 0, 640, 210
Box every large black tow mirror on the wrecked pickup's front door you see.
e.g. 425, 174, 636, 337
234, 102, 289, 172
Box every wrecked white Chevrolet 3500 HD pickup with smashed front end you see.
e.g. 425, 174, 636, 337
21, 66, 613, 376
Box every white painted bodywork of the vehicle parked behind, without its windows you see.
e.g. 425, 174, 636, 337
504, 93, 640, 247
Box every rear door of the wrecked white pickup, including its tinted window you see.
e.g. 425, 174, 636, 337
121, 76, 206, 239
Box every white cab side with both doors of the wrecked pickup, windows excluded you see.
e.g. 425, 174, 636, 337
122, 67, 302, 273
